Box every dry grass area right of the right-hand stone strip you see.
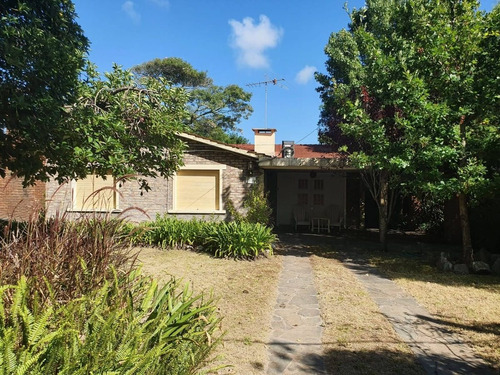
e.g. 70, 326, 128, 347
372, 257, 500, 373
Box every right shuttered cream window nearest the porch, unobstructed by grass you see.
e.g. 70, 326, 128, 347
174, 167, 223, 213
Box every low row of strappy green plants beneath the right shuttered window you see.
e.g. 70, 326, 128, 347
128, 216, 276, 258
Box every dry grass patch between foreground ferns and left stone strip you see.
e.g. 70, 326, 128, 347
134, 248, 281, 375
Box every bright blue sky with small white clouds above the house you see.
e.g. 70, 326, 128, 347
74, 0, 498, 143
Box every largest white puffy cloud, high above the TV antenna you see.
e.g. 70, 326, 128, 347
229, 15, 283, 68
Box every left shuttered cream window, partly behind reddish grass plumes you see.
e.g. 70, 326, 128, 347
73, 175, 117, 211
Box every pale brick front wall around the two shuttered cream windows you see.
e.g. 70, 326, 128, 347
47, 141, 252, 221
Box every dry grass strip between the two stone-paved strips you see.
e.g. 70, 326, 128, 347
311, 255, 423, 375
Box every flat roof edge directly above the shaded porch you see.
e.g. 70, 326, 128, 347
259, 157, 356, 170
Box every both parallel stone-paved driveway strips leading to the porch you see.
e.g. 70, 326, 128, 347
267, 239, 493, 375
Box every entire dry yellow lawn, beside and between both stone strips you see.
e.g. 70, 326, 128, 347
131, 236, 500, 375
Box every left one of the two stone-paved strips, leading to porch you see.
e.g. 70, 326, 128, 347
267, 255, 326, 375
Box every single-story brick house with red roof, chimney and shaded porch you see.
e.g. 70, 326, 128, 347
0, 128, 364, 229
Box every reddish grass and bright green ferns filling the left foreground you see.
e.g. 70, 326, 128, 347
0, 216, 223, 375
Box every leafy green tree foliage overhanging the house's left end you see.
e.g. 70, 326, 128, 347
0, 0, 188, 189
